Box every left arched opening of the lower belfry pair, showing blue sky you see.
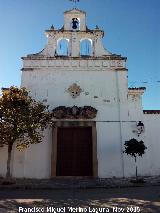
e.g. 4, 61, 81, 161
57, 39, 69, 56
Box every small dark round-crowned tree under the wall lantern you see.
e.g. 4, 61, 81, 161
124, 138, 147, 179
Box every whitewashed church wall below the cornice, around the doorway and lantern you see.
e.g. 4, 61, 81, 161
0, 63, 160, 178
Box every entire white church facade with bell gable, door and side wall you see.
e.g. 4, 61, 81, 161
0, 9, 160, 178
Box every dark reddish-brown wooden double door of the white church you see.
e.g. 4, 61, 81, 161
56, 127, 93, 176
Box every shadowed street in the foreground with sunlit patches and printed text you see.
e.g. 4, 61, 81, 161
0, 186, 160, 213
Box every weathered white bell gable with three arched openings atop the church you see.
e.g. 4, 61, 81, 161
39, 9, 111, 57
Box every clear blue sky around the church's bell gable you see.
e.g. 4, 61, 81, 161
0, 0, 160, 109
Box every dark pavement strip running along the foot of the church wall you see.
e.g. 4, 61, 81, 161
0, 176, 160, 191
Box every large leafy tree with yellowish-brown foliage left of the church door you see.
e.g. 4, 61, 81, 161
0, 86, 52, 178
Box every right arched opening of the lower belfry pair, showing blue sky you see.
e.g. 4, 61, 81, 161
80, 39, 93, 56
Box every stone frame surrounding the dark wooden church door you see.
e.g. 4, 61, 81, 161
51, 121, 98, 178
